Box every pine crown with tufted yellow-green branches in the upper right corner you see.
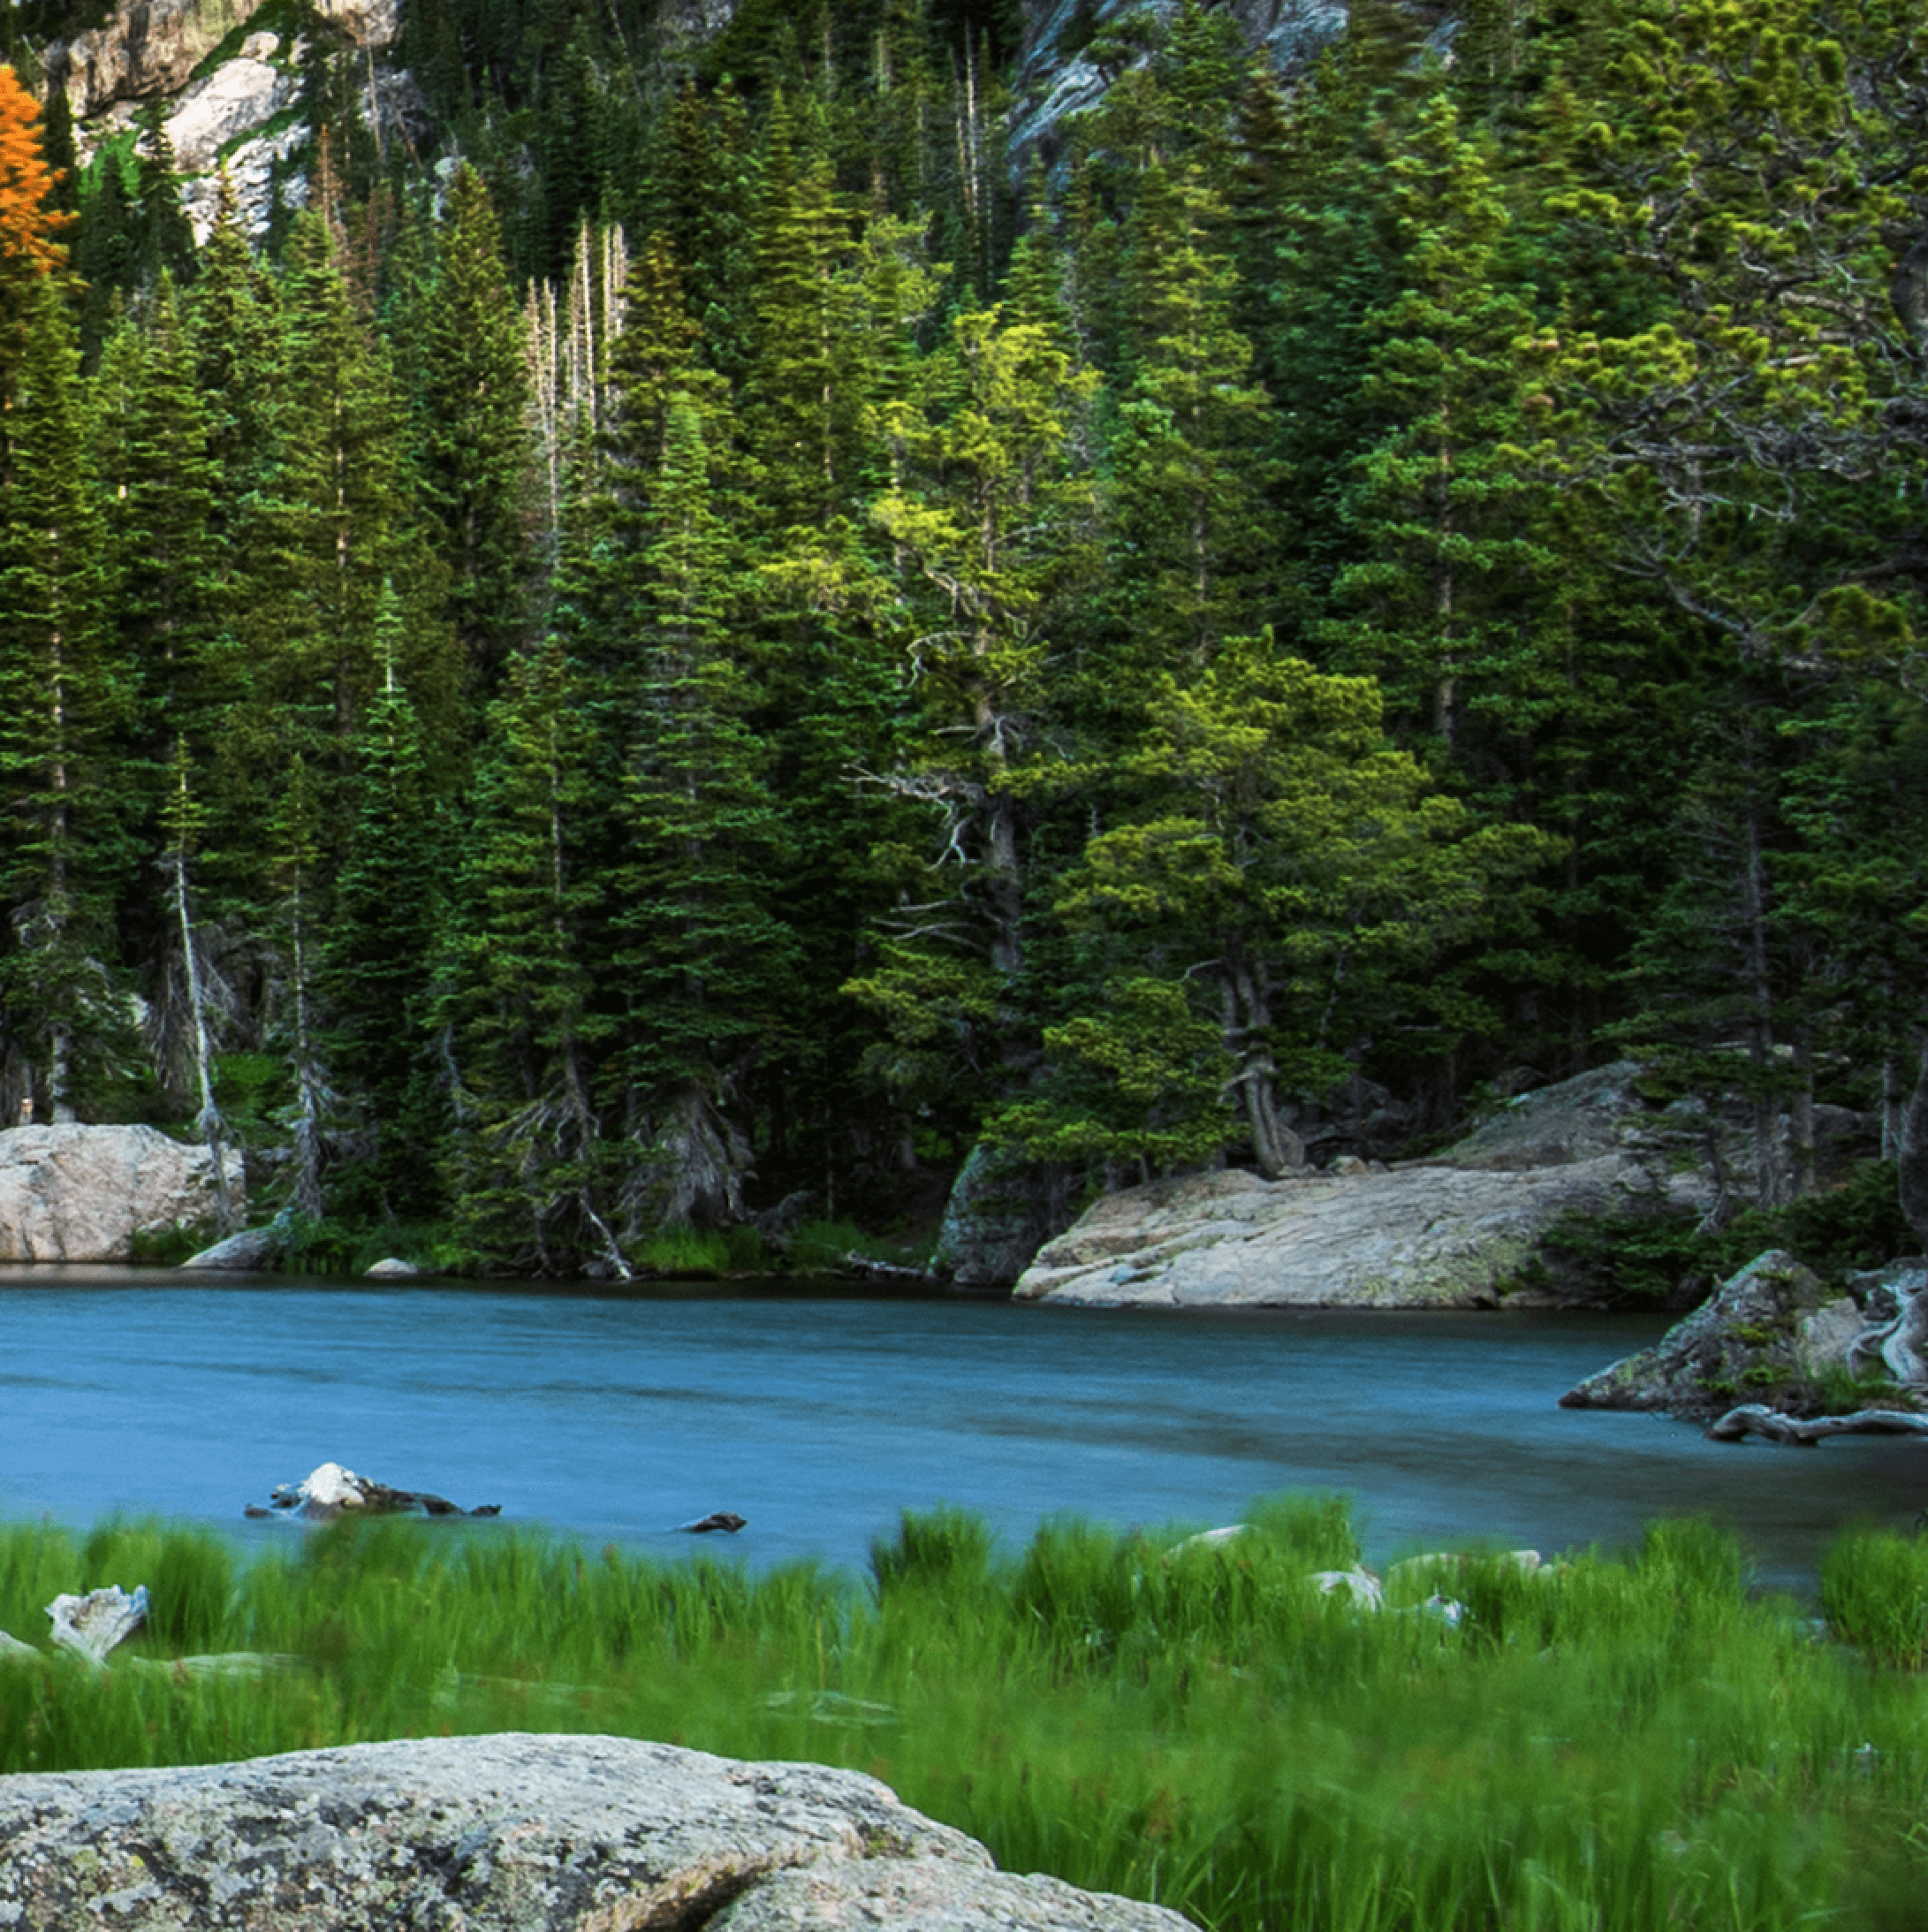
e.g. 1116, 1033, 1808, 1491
1547, 0, 1928, 661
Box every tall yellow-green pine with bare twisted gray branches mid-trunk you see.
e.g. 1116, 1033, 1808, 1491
850, 293, 1097, 1151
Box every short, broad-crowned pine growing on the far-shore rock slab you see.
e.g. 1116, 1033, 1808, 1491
1028, 635, 1549, 1175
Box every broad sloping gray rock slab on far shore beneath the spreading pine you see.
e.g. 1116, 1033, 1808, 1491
1016, 1153, 1692, 1308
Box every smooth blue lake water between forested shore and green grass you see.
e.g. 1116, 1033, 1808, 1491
0, 1267, 1928, 1585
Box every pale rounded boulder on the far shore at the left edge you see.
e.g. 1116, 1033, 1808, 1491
0, 1124, 246, 1261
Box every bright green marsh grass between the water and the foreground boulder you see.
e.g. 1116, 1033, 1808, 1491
0, 1502, 1928, 1932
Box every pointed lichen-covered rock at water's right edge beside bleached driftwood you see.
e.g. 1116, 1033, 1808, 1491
1561, 1248, 1831, 1419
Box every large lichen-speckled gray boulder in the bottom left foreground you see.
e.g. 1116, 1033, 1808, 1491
0, 1735, 1186, 1932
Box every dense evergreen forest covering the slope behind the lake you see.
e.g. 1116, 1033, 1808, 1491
0, 0, 1928, 1275
